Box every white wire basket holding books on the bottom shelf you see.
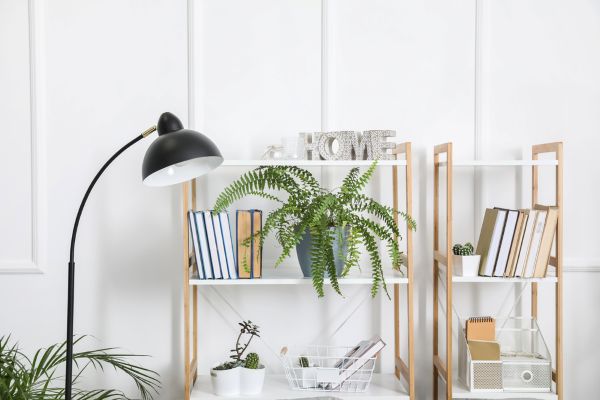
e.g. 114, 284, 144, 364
281, 345, 377, 392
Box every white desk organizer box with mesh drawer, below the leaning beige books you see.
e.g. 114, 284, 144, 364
459, 318, 552, 392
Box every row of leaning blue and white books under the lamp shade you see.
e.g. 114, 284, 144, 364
188, 210, 238, 279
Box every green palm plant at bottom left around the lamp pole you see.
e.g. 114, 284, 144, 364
0, 336, 160, 400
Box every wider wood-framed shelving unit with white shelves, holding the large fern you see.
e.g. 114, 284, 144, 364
181, 143, 416, 400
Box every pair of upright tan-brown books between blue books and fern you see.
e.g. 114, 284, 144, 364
236, 210, 262, 279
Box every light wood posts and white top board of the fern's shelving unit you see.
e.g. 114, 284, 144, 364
181, 142, 416, 400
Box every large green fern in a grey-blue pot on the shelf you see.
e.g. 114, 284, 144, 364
214, 161, 415, 297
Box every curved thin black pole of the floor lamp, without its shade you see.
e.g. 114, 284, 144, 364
65, 126, 156, 400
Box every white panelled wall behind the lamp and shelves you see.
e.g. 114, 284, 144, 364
0, 0, 600, 399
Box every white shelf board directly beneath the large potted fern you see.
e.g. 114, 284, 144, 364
190, 265, 408, 286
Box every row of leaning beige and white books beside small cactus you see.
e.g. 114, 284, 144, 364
476, 205, 558, 278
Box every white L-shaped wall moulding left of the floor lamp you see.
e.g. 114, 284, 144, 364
0, 0, 47, 274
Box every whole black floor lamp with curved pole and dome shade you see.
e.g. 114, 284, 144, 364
65, 112, 223, 400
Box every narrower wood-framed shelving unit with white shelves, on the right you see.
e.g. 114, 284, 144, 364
433, 143, 563, 400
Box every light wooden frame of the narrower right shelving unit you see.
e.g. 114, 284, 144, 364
433, 142, 564, 400
